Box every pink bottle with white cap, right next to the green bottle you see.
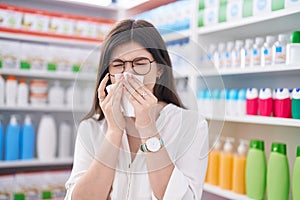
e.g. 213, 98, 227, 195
274, 88, 292, 118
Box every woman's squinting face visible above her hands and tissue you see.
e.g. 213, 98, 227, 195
109, 42, 160, 92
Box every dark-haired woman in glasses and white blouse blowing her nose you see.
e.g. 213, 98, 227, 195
65, 20, 208, 200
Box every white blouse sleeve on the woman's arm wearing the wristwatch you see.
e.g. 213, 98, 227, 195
152, 115, 208, 200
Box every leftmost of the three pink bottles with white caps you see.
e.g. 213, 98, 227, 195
246, 88, 258, 115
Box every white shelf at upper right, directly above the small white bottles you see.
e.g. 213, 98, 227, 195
198, 5, 300, 35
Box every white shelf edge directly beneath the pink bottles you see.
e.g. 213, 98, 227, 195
206, 115, 300, 127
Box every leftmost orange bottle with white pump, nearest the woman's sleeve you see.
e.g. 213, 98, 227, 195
206, 140, 221, 185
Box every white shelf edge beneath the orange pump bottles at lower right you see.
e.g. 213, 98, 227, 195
203, 183, 251, 200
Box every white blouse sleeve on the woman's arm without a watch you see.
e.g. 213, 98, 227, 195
65, 121, 94, 200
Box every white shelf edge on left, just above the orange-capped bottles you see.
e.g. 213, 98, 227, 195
0, 69, 95, 81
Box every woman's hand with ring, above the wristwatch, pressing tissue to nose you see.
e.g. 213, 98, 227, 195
124, 74, 161, 138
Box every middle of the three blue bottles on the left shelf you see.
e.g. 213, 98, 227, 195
4, 115, 20, 160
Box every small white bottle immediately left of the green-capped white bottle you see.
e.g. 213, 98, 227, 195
261, 35, 276, 66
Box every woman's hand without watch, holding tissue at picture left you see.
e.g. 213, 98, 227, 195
98, 74, 125, 132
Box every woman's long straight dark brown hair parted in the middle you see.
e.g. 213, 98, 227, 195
84, 19, 183, 120
